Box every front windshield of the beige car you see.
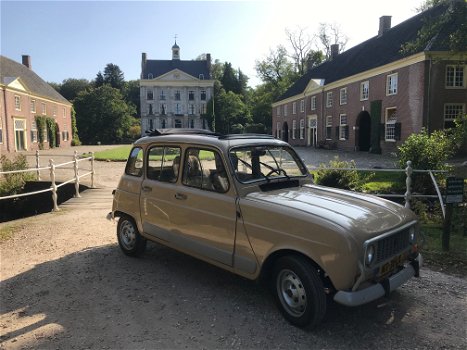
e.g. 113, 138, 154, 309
229, 146, 307, 183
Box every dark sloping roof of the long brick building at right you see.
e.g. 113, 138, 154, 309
277, 4, 460, 101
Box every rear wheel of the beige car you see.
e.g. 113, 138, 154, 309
117, 215, 147, 256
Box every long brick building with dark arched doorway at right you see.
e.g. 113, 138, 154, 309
272, 2, 467, 153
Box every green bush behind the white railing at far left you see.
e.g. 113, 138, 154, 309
0, 154, 34, 197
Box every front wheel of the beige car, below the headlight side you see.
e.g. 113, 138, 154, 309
271, 255, 327, 328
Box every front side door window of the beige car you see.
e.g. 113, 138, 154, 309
183, 148, 229, 193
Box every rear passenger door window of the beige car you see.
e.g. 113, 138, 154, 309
146, 146, 181, 183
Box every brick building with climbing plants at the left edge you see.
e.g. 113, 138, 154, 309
0, 55, 72, 154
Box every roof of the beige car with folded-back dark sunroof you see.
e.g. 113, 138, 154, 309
134, 128, 289, 151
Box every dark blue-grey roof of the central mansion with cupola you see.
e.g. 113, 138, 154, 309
143, 60, 211, 79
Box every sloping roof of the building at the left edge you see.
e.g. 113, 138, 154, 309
0, 55, 71, 104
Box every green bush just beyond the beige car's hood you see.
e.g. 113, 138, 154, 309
316, 156, 374, 191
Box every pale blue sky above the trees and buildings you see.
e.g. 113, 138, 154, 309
0, 0, 422, 86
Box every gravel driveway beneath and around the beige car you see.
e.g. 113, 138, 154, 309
0, 146, 467, 349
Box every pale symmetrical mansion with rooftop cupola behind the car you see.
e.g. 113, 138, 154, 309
140, 42, 214, 136
